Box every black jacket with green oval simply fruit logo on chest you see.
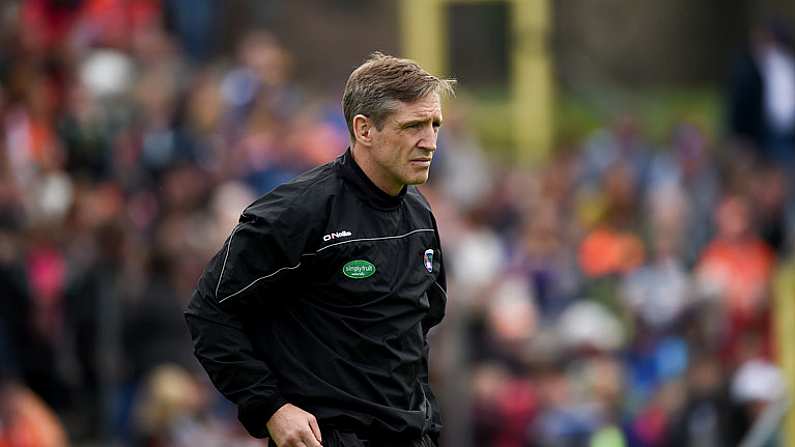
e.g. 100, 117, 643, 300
185, 151, 446, 437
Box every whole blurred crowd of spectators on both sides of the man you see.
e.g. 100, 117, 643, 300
0, 0, 795, 447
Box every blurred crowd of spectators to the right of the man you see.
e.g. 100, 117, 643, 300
442, 18, 795, 447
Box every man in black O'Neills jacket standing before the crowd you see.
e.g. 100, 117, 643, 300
185, 53, 454, 447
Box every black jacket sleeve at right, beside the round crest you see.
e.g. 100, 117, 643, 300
420, 222, 447, 445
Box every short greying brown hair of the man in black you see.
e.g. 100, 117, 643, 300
342, 51, 456, 141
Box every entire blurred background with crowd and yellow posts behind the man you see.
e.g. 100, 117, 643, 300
0, 0, 795, 447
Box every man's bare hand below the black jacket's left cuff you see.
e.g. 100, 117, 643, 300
267, 404, 323, 447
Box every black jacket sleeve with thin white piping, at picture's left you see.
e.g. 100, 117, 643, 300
185, 193, 309, 438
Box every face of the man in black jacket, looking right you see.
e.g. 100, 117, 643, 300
370, 93, 442, 194
